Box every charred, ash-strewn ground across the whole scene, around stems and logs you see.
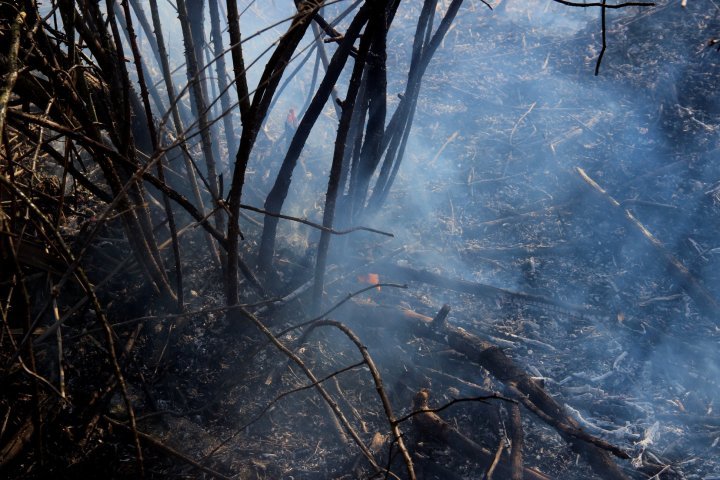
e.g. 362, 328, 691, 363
8, 1, 720, 480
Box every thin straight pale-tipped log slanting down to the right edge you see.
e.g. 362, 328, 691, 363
575, 167, 720, 318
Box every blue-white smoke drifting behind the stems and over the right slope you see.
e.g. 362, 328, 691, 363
141, 0, 720, 474
